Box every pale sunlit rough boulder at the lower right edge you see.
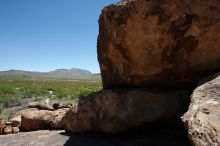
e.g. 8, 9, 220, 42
182, 73, 220, 146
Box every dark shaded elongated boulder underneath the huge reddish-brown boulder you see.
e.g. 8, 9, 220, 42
62, 89, 188, 133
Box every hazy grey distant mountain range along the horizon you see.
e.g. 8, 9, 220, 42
0, 68, 101, 79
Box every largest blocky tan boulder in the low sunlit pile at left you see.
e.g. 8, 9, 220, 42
21, 108, 69, 131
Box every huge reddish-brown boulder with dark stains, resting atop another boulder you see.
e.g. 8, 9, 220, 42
98, 0, 220, 88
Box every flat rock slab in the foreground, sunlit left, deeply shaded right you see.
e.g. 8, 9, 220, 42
0, 126, 190, 146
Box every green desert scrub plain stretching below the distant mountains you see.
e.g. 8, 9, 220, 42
0, 78, 102, 116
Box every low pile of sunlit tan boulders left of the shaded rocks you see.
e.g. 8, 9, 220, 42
0, 102, 72, 135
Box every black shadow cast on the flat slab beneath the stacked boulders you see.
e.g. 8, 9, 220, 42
63, 123, 191, 146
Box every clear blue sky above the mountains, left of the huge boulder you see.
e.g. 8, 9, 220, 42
0, 0, 118, 73
